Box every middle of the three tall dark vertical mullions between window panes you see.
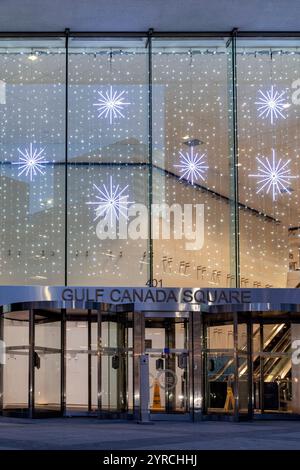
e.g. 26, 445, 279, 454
147, 29, 153, 286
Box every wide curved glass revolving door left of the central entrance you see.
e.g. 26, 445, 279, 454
0, 303, 133, 418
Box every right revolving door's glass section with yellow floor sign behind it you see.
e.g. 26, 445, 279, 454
204, 314, 251, 418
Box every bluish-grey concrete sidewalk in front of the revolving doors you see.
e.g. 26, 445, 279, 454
0, 418, 300, 450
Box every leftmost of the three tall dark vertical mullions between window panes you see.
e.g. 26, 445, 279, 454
64, 29, 70, 286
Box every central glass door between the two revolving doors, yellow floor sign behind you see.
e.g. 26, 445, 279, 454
145, 318, 189, 413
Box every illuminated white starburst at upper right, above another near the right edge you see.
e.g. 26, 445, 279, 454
255, 85, 287, 124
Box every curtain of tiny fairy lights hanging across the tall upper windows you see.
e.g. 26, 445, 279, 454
0, 47, 300, 287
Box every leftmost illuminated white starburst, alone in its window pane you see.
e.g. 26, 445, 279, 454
12, 144, 49, 181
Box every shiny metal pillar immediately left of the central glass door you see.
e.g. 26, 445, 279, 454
133, 312, 145, 420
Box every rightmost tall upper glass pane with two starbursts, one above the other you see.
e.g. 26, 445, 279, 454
237, 38, 300, 287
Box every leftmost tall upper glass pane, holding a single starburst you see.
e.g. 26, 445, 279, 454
0, 39, 65, 285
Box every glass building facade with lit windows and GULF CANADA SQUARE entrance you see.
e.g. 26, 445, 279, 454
0, 31, 300, 419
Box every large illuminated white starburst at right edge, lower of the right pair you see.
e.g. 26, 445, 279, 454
249, 149, 298, 201
